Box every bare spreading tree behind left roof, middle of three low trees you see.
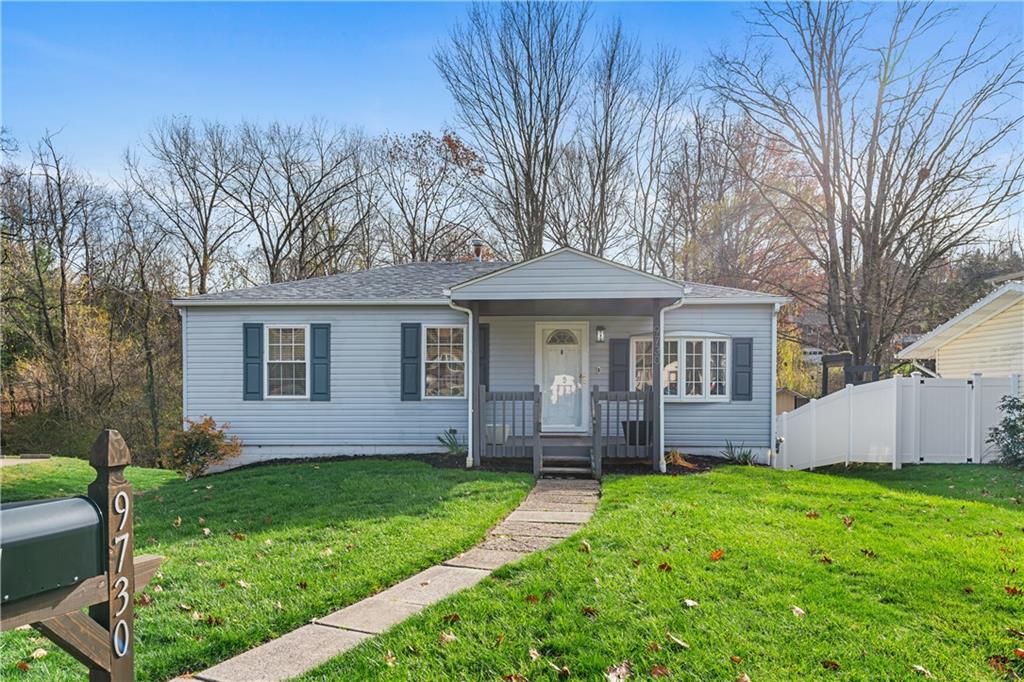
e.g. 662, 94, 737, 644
225, 122, 358, 282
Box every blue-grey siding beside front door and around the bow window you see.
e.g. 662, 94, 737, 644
481, 304, 772, 450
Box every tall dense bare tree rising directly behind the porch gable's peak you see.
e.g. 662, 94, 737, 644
434, 0, 590, 258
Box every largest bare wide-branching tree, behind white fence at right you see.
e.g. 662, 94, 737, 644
710, 2, 1024, 363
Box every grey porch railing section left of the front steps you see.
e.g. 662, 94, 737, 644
475, 385, 542, 475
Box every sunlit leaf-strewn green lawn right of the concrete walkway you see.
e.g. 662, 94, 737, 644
306, 466, 1024, 682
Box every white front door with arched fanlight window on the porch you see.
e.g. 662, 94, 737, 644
537, 323, 590, 432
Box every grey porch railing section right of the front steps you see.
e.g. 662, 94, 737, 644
590, 389, 655, 476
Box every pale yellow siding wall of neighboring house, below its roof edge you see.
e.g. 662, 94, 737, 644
935, 300, 1024, 378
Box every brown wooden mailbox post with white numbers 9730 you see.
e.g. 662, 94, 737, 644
0, 429, 163, 682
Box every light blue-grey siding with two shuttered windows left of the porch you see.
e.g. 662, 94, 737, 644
184, 306, 467, 448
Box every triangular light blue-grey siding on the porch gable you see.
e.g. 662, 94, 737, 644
453, 251, 683, 301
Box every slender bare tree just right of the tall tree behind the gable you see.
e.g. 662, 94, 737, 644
549, 24, 640, 256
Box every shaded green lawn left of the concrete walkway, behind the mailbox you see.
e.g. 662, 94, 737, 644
0, 458, 530, 680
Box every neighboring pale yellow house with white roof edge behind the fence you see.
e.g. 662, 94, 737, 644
896, 282, 1024, 379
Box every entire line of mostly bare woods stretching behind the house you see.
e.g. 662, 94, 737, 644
0, 2, 1024, 457
